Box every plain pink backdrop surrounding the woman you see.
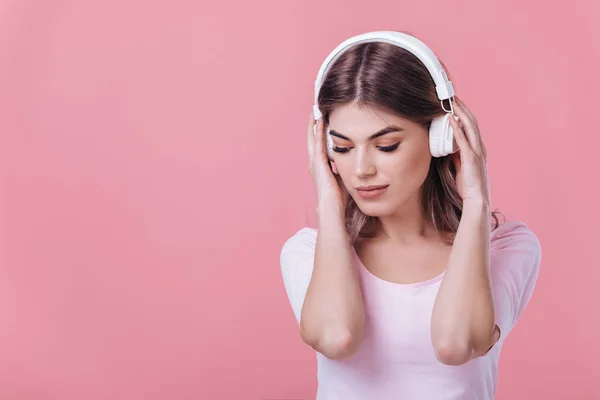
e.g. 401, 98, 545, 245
0, 0, 600, 400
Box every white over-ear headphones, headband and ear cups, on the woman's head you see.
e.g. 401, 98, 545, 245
313, 31, 458, 159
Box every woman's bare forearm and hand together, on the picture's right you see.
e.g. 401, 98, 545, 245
431, 97, 499, 365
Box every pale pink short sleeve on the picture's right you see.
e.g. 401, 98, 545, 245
490, 221, 542, 343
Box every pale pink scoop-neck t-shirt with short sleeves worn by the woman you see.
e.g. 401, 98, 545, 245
280, 221, 541, 400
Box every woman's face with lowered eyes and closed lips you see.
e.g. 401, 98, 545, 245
328, 104, 431, 217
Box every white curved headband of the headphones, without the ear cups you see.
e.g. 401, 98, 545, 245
313, 31, 454, 120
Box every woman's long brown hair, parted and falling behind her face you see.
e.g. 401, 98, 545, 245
318, 37, 499, 244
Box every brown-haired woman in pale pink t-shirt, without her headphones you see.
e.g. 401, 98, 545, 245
281, 32, 541, 400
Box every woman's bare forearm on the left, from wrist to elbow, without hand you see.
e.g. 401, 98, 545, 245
300, 201, 364, 359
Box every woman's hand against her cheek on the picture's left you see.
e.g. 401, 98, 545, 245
307, 112, 348, 212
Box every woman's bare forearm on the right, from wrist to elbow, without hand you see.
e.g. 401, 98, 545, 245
431, 201, 499, 365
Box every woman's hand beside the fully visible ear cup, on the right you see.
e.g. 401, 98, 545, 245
450, 96, 490, 205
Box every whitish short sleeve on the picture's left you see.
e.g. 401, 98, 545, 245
279, 227, 317, 324
